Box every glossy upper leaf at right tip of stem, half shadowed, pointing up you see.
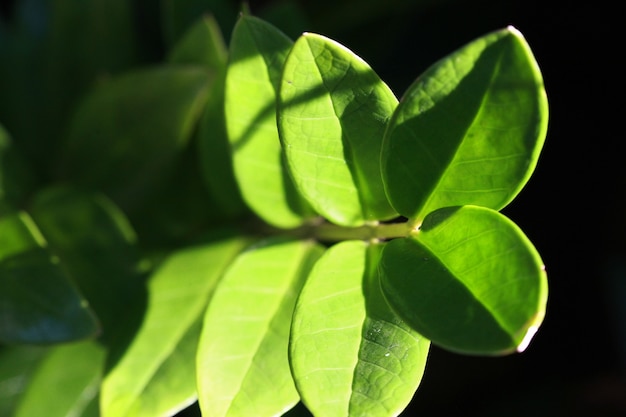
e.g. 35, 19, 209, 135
382, 27, 548, 221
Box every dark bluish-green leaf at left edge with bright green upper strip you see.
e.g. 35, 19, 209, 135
0, 212, 99, 343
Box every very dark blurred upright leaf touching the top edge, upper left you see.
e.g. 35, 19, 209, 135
43, 0, 136, 162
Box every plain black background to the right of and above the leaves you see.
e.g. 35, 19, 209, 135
0, 0, 626, 417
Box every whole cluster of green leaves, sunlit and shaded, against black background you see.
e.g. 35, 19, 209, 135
0, 0, 548, 417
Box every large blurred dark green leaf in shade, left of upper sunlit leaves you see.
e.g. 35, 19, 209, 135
62, 65, 213, 210
